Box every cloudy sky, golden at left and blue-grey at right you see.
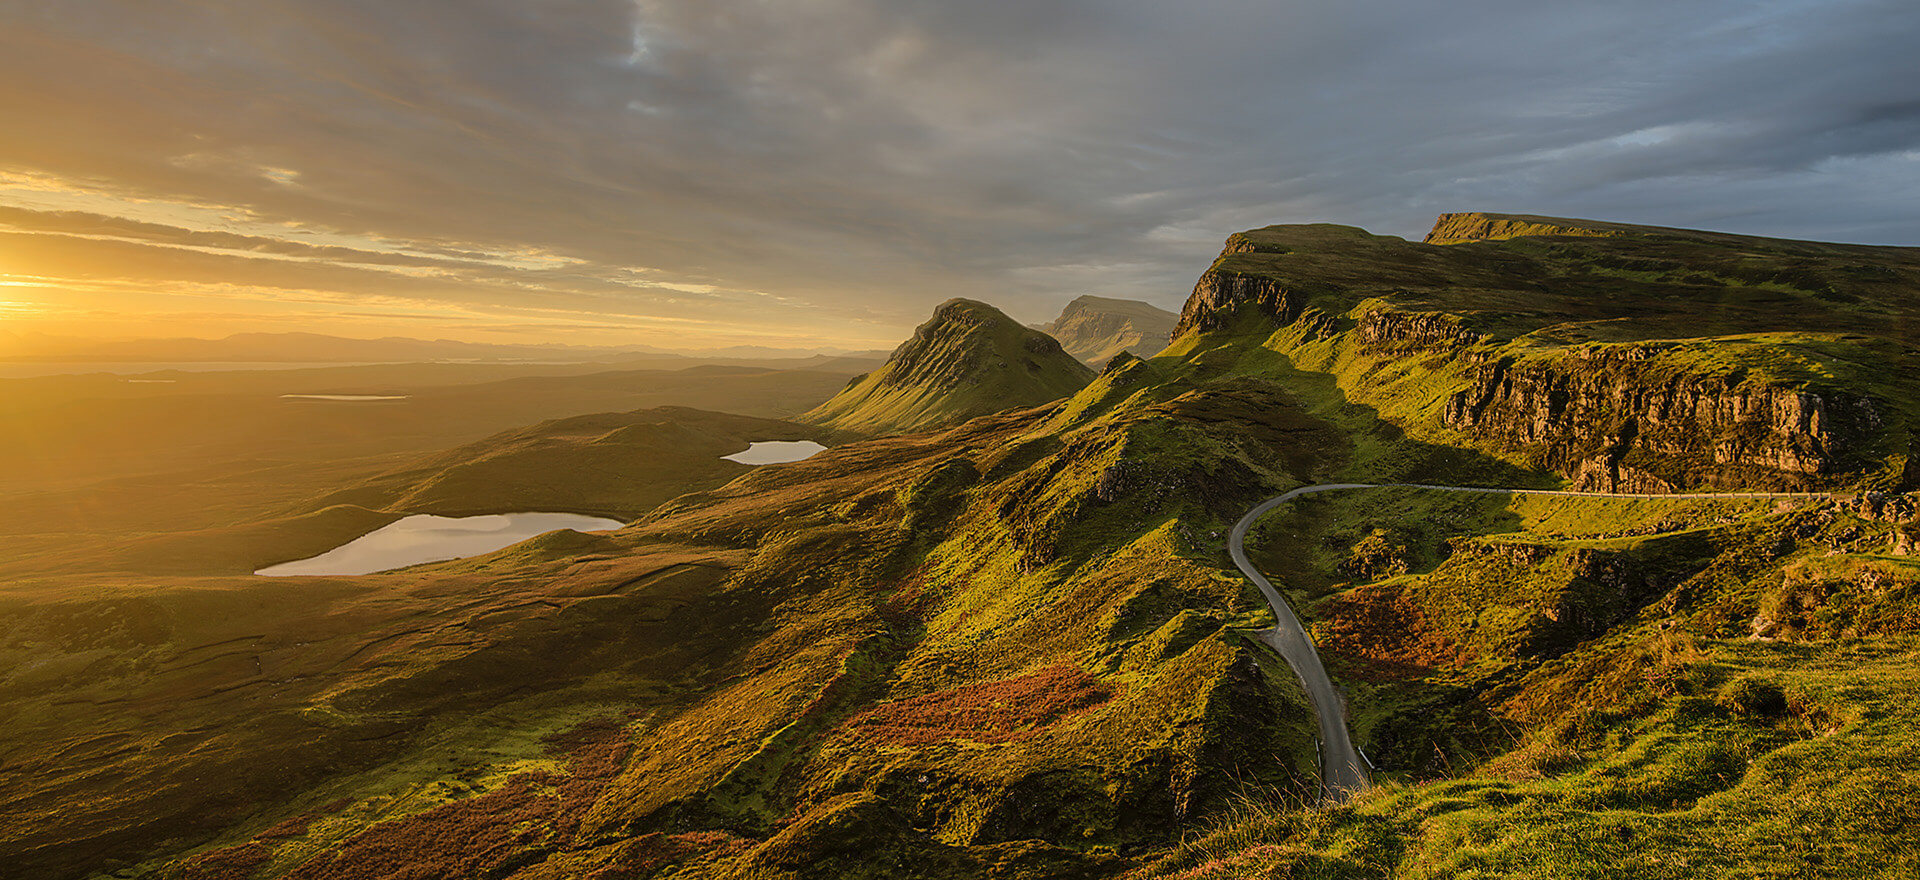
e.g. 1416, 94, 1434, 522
0, 0, 1920, 355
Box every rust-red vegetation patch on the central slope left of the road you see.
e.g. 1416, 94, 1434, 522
843, 665, 1112, 746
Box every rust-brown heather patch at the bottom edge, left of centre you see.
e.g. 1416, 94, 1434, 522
272, 719, 630, 880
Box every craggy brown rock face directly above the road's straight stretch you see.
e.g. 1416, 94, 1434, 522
1444, 346, 1882, 492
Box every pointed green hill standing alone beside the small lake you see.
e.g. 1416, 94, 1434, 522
801, 300, 1092, 434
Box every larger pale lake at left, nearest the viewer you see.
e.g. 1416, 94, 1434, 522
253, 513, 624, 576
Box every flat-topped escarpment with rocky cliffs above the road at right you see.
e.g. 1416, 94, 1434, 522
1175, 213, 1920, 492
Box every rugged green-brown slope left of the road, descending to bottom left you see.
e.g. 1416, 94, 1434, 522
6, 386, 1338, 876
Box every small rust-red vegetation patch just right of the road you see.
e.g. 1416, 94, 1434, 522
1313, 584, 1463, 682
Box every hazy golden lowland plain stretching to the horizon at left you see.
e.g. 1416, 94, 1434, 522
0, 361, 862, 574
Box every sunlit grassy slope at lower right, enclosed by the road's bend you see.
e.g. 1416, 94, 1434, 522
1129, 490, 1920, 880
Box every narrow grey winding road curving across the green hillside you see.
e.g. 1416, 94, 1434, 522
1227, 482, 1851, 801
